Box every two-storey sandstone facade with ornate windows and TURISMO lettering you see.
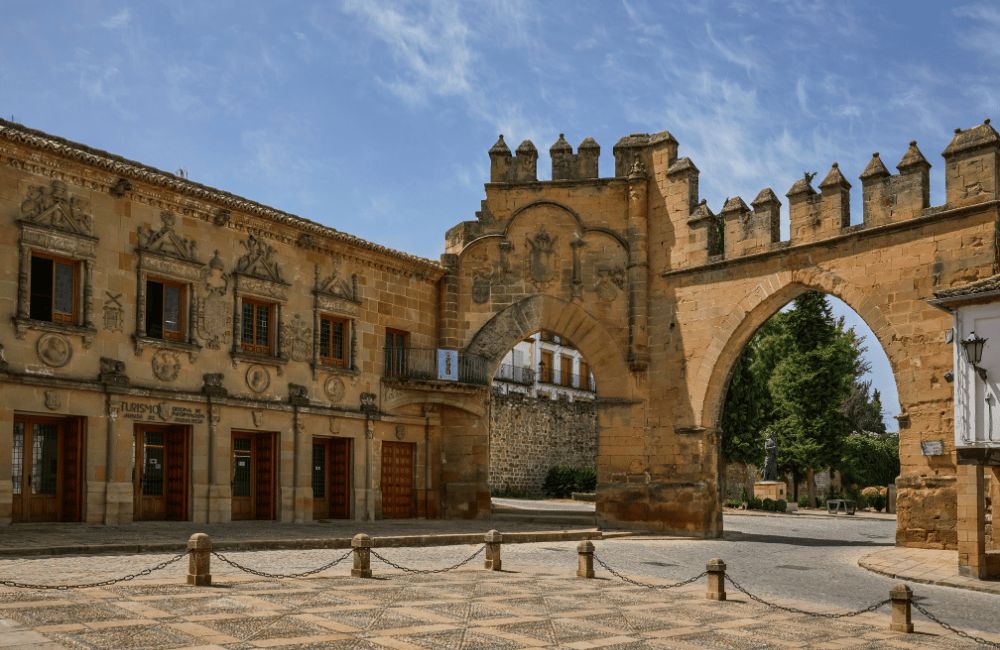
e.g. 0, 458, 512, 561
0, 117, 486, 523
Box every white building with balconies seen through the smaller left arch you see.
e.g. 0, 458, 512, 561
493, 332, 597, 401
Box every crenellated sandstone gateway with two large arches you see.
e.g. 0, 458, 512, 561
439, 120, 1000, 548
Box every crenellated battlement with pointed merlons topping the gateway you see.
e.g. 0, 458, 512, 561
470, 120, 1000, 269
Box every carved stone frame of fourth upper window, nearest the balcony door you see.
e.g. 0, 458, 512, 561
312, 264, 361, 379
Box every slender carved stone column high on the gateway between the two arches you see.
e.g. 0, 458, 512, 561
626, 160, 649, 370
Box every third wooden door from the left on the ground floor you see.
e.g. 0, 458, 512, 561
232, 431, 278, 521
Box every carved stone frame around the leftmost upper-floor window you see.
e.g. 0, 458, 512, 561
12, 180, 99, 348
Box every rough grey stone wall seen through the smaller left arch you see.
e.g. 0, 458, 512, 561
490, 393, 597, 494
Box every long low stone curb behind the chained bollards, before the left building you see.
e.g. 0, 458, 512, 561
0, 529, 616, 557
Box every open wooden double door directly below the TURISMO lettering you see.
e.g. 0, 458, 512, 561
133, 424, 191, 521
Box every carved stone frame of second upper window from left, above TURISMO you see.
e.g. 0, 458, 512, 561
132, 211, 206, 361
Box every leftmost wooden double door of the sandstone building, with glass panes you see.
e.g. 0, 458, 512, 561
11, 416, 83, 522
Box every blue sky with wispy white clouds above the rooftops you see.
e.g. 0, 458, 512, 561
0, 0, 1000, 430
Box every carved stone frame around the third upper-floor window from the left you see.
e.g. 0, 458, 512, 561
230, 234, 291, 375
